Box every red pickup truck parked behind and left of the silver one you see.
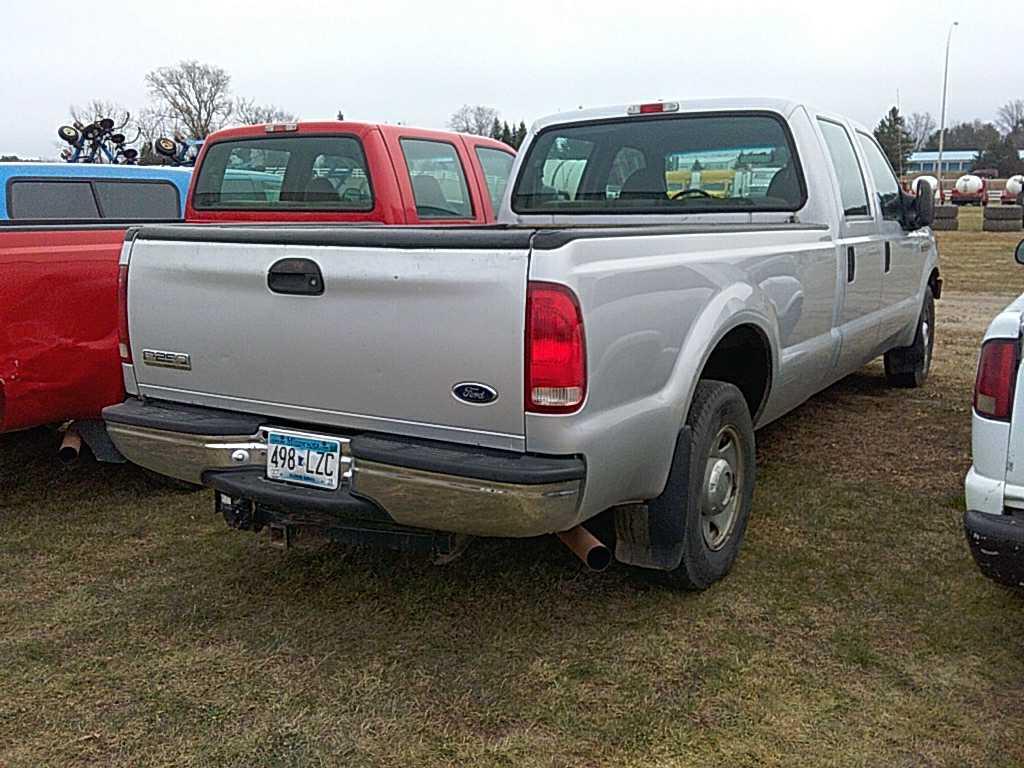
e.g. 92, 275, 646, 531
0, 122, 514, 455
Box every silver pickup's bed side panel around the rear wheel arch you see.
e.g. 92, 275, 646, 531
526, 227, 837, 518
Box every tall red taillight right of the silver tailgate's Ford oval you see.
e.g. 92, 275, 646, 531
526, 283, 587, 414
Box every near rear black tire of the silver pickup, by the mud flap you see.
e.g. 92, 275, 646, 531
649, 380, 756, 590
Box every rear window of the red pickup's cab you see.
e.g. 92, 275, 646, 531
193, 135, 374, 211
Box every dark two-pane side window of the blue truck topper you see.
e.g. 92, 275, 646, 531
7, 178, 181, 221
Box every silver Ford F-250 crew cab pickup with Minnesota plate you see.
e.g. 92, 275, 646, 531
104, 100, 941, 589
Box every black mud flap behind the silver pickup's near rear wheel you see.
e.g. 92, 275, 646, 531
615, 426, 692, 570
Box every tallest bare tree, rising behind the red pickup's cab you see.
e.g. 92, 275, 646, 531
145, 60, 232, 138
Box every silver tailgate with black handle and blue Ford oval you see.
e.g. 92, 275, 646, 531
128, 228, 529, 450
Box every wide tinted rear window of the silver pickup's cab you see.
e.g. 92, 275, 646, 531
512, 114, 806, 214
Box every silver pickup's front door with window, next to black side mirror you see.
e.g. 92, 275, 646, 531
857, 131, 929, 348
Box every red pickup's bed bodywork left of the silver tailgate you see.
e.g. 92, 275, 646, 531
0, 225, 125, 431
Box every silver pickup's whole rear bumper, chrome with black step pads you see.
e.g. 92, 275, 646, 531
103, 398, 586, 537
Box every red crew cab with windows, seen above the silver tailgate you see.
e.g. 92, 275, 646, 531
185, 122, 515, 224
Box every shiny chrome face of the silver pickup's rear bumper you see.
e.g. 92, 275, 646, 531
104, 415, 584, 538
